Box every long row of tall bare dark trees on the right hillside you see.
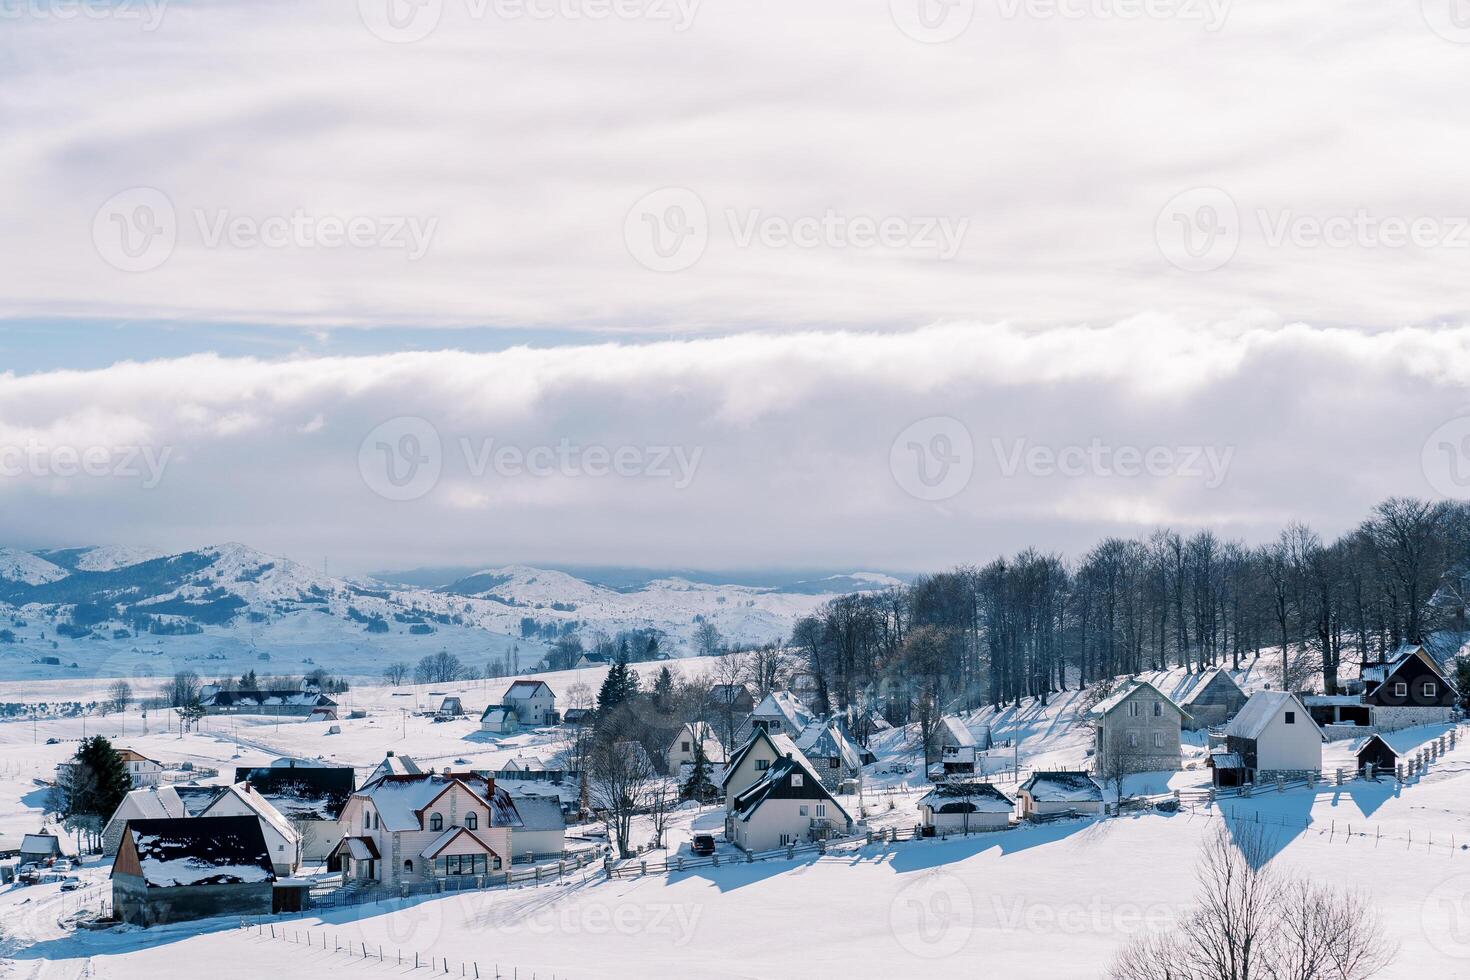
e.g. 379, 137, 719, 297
791, 498, 1470, 724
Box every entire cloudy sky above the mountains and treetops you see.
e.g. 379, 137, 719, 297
0, 0, 1470, 570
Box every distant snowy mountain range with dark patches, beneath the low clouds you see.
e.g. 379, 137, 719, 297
0, 544, 900, 676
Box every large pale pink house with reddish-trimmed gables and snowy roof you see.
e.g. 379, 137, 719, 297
332, 773, 522, 887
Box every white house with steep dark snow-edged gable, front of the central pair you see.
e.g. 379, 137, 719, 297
728, 752, 854, 851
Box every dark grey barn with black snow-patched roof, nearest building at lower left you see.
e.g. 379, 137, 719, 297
112, 817, 276, 926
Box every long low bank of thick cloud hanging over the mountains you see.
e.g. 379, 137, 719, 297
0, 314, 1470, 569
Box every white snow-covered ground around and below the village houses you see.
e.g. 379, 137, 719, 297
0, 661, 1470, 980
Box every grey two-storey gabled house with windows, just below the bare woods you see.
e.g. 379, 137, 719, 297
1088, 680, 1189, 776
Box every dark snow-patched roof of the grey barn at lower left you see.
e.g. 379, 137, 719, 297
112, 817, 275, 887
